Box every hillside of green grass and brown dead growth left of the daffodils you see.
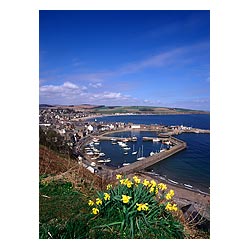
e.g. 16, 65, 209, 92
39, 146, 207, 239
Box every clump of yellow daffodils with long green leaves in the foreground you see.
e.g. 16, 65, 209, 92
85, 174, 182, 238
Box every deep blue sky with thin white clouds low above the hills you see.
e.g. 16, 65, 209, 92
39, 10, 210, 110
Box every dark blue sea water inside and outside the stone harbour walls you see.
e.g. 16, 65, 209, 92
87, 115, 210, 192
